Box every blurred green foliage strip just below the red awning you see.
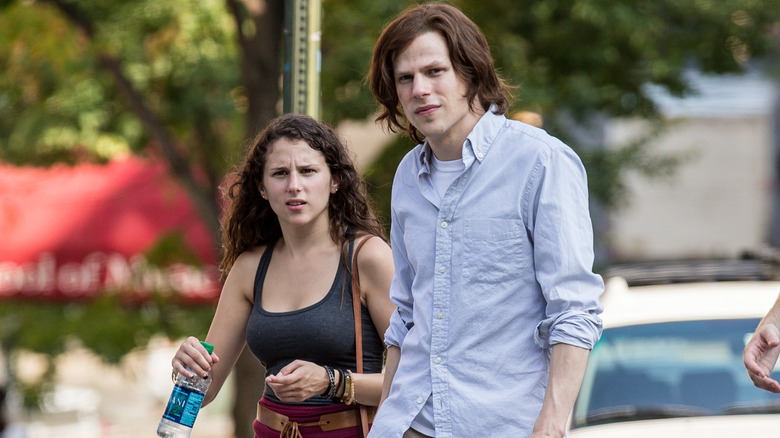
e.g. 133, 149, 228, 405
0, 294, 214, 406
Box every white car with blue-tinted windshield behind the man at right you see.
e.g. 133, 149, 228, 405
568, 261, 780, 438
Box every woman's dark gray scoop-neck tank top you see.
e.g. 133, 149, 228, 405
246, 240, 384, 405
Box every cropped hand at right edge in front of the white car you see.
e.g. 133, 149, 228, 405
742, 297, 780, 393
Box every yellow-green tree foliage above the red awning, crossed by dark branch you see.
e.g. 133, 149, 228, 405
0, 0, 243, 172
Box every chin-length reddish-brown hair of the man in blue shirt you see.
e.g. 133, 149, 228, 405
368, 3, 511, 143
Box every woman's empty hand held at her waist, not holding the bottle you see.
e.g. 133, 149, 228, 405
265, 360, 330, 402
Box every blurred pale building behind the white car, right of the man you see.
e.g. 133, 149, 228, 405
597, 73, 780, 262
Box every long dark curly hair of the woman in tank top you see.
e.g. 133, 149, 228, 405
219, 114, 385, 281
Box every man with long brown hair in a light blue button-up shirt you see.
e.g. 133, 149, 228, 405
369, 4, 604, 438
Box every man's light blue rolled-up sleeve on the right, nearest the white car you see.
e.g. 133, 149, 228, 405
526, 148, 604, 349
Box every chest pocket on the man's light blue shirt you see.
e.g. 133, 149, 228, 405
463, 219, 528, 288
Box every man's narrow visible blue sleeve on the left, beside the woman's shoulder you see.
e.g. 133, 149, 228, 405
385, 200, 414, 347
